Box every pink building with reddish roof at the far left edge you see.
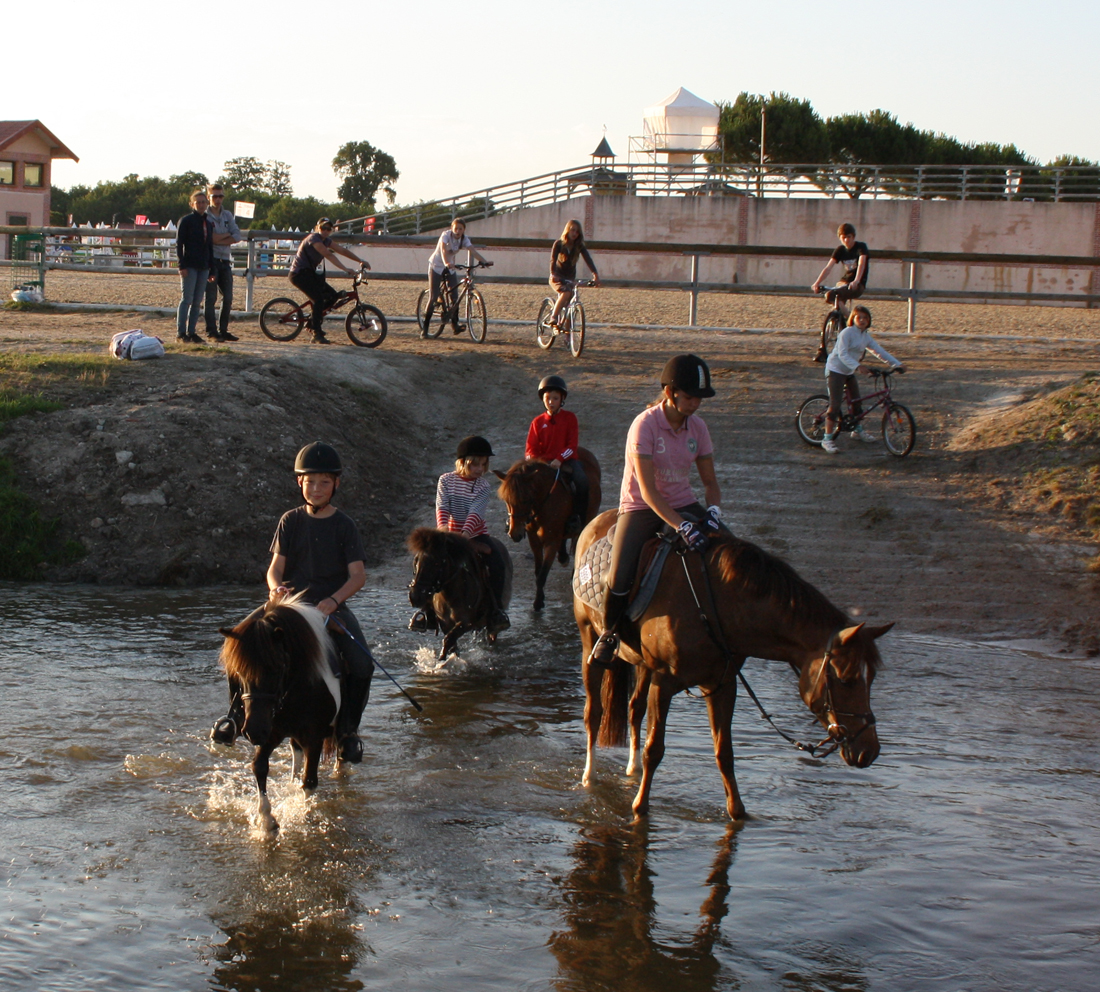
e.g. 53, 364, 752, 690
0, 121, 80, 258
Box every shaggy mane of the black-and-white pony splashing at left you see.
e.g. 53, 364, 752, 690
221, 597, 323, 683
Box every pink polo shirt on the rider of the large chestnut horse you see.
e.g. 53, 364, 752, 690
619, 404, 714, 512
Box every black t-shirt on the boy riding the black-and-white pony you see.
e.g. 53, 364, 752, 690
271, 506, 366, 605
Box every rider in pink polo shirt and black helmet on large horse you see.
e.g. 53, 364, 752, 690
590, 355, 722, 665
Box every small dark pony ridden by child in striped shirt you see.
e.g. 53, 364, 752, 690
405, 527, 512, 661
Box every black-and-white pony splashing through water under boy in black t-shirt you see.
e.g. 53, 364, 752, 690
219, 597, 340, 833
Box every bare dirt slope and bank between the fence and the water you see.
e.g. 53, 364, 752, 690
0, 312, 1100, 650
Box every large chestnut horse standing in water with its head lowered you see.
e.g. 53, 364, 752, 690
573, 510, 893, 819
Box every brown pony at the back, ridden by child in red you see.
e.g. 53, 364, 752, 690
494, 448, 603, 609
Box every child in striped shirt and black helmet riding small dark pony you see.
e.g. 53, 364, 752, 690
409, 434, 512, 633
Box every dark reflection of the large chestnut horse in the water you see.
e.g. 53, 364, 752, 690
550, 820, 738, 992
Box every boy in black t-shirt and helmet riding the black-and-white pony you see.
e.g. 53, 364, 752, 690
210, 441, 374, 764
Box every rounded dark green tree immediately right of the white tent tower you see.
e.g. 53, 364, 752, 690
708, 92, 829, 163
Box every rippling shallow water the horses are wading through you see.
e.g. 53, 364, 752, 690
0, 580, 1100, 992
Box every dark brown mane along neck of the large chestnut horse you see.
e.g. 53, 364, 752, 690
711, 533, 862, 653
